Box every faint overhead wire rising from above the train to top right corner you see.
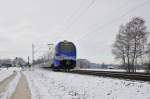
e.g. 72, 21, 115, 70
77, 0, 150, 41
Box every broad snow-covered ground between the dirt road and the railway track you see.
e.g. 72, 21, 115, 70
24, 69, 150, 99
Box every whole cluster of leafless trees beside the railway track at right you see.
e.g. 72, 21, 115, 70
112, 17, 150, 72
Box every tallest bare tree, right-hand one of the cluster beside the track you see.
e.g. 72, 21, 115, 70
127, 17, 148, 72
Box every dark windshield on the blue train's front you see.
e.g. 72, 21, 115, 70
60, 43, 75, 52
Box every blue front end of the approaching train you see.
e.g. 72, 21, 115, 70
51, 40, 77, 71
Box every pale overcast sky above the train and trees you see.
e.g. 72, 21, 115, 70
0, 0, 150, 63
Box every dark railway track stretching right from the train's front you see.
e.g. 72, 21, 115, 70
69, 70, 150, 81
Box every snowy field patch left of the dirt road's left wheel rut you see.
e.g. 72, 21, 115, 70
0, 67, 20, 81
